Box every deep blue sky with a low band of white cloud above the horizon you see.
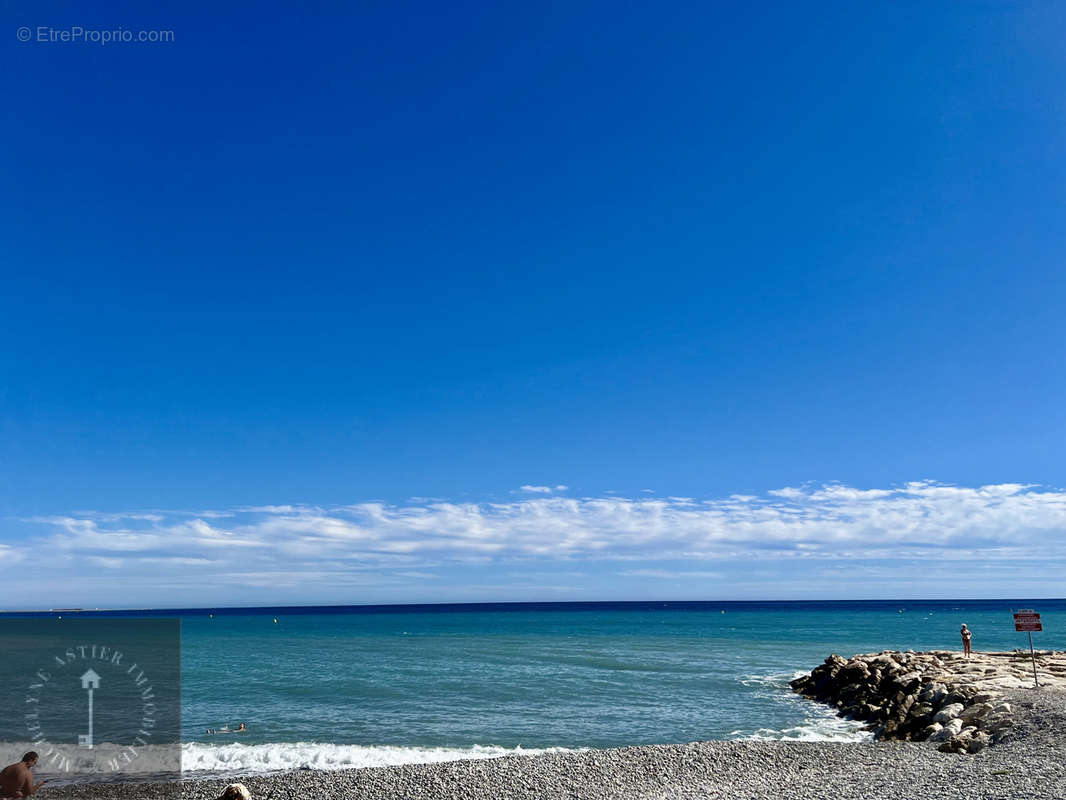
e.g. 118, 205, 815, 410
0, 2, 1066, 607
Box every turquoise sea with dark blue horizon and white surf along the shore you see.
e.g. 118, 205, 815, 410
0, 598, 1066, 783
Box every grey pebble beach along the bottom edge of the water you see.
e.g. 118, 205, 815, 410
42, 688, 1066, 800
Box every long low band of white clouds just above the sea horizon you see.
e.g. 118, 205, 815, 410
8, 481, 1066, 605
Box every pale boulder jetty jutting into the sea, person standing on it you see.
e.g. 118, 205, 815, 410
792, 650, 1066, 753
